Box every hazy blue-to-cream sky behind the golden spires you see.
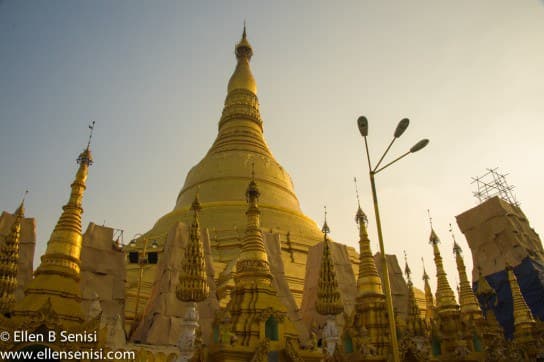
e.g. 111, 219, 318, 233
0, 0, 544, 294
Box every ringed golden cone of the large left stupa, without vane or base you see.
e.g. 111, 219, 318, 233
12, 146, 93, 329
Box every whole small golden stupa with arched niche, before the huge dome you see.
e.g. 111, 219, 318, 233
212, 173, 297, 361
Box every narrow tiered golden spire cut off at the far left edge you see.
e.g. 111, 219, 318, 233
0, 191, 28, 314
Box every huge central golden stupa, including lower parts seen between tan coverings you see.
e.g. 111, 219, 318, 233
126, 27, 321, 321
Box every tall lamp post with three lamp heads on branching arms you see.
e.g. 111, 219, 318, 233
357, 116, 429, 362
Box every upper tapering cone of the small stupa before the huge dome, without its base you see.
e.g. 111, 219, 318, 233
236, 165, 272, 283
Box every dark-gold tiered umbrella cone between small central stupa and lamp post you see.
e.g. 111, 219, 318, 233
315, 209, 344, 315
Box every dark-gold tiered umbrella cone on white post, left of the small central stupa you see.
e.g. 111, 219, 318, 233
180, 193, 210, 302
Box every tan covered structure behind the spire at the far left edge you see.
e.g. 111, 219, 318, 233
0, 211, 36, 301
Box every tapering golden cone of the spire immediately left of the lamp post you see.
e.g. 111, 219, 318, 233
355, 206, 383, 297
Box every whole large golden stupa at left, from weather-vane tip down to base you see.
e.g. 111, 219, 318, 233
0, 128, 100, 350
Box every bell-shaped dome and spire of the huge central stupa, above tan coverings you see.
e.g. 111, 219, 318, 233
148, 29, 321, 246
